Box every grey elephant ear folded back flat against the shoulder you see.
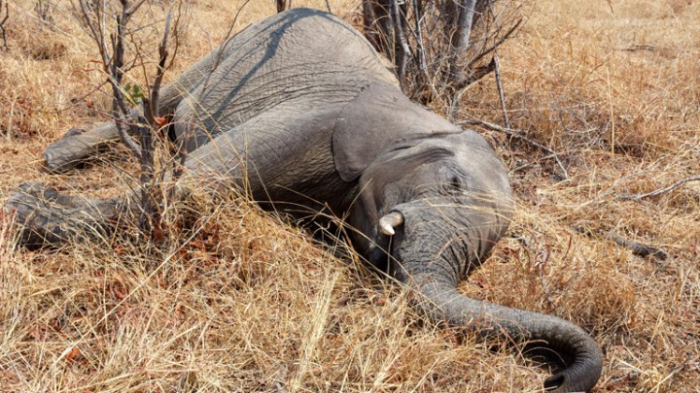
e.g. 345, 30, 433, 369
332, 83, 462, 182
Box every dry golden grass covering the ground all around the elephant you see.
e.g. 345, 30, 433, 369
0, 0, 700, 392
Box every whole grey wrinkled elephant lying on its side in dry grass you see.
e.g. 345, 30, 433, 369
6, 9, 602, 392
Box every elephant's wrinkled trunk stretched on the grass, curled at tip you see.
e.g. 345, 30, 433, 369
399, 270, 603, 392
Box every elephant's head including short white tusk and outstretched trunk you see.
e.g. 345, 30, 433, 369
348, 131, 602, 392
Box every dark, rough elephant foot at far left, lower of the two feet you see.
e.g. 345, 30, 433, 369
3, 182, 119, 248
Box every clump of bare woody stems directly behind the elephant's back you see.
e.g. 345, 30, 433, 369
362, 0, 522, 107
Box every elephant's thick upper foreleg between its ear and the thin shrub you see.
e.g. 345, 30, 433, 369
181, 103, 342, 208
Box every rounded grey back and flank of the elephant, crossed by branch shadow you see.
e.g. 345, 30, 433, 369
171, 8, 398, 145
